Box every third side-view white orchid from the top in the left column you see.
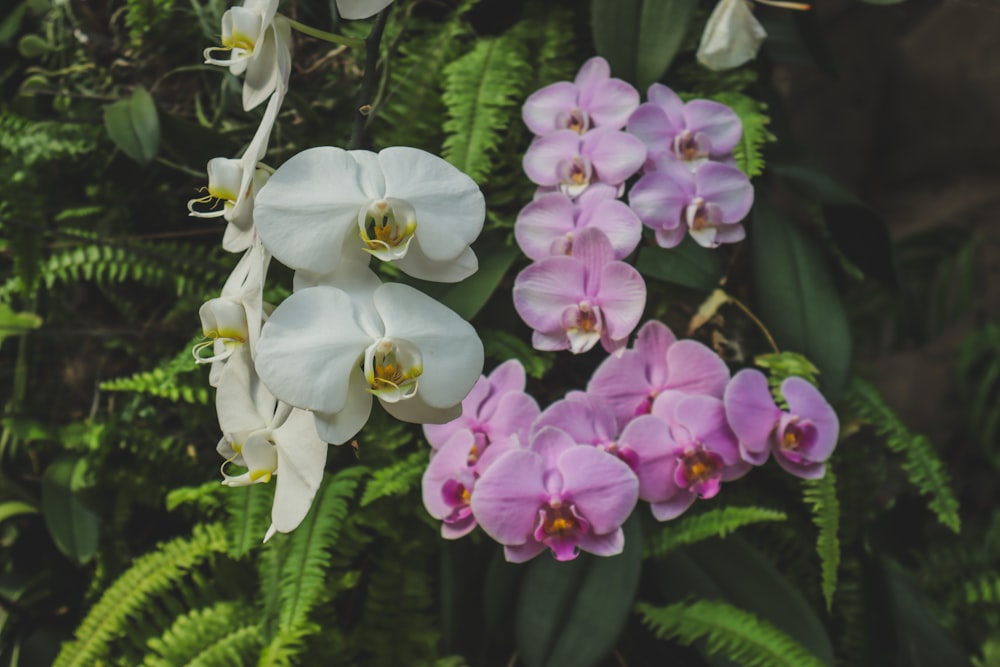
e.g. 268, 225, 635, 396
193, 236, 271, 387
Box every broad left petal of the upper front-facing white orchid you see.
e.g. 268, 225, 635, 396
254, 146, 368, 273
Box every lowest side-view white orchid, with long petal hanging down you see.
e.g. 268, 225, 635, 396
216, 352, 328, 541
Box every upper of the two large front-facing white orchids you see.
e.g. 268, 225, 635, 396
254, 146, 486, 282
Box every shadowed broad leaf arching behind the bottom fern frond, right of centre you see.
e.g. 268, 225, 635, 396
658, 535, 834, 667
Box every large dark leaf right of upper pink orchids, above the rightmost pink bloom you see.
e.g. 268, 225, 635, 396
750, 201, 851, 401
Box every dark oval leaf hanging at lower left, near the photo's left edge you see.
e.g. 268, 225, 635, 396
42, 457, 98, 565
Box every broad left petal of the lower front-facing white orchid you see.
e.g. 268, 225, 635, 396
256, 287, 372, 413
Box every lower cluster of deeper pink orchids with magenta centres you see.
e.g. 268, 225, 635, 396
423, 321, 839, 562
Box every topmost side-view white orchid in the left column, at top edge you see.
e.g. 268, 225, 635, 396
205, 0, 292, 111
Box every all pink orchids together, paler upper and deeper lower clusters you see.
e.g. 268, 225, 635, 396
423, 58, 839, 562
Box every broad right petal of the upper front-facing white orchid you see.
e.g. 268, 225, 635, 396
378, 146, 486, 260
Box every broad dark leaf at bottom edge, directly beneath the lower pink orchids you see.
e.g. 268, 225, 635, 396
515, 516, 642, 667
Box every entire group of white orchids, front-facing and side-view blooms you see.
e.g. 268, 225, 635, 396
188, 0, 486, 539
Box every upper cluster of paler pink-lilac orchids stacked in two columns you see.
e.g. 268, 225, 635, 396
514, 57, 753, 354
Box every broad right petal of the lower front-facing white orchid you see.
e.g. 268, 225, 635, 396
374, 283, 483, 408
